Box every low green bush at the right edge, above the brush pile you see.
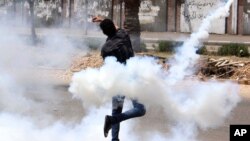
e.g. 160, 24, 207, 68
218, 44, 249, 57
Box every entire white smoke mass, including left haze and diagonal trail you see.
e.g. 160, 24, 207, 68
0, 0, 240, 141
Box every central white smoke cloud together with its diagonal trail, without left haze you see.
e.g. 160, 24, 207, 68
69, 0, 240, 141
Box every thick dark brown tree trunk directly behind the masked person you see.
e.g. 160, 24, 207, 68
124, 0, 142, 52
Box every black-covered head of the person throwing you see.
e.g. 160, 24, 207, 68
100, 19, 116, 37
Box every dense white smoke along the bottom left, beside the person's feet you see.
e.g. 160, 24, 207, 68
0, 103, 141, 141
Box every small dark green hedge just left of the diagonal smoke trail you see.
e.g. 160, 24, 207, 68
158, 41, 183, 52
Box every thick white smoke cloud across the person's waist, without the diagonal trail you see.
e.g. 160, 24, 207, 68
69, 57, 239, 140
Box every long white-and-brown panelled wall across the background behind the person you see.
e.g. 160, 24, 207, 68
0, 0, 250, 35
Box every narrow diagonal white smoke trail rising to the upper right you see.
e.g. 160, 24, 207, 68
169, 0, 234, 83
